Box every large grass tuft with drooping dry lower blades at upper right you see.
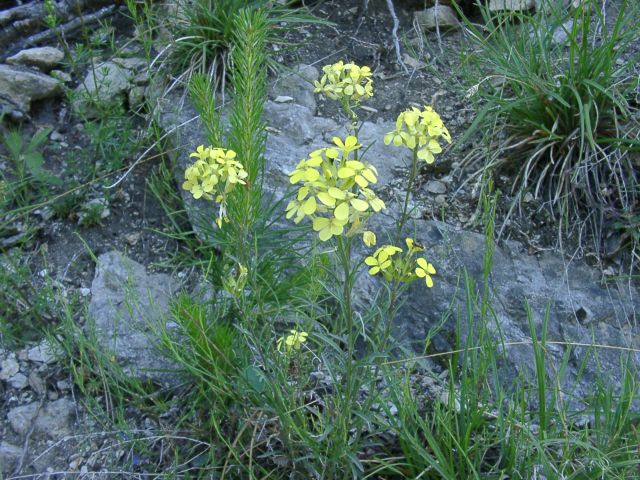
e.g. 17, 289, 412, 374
466, 0, 640, 253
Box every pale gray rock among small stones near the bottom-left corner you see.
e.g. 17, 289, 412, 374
7, 398, 75, 440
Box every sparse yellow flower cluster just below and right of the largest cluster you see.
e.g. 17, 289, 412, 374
364, 238, 436, 288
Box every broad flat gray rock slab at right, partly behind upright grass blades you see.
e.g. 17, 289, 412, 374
358, 220, 640, 401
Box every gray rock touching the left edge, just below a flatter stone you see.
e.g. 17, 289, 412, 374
0, 65, 62, 112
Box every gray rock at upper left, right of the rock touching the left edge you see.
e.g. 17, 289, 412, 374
73, 58, 146, 117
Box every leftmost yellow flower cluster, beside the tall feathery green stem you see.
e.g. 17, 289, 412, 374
182, 145, 249, 226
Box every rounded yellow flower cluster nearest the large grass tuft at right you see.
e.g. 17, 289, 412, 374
384, 107, 451, 163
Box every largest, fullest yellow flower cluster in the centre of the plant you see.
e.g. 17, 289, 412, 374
286, 136, 385, 242
